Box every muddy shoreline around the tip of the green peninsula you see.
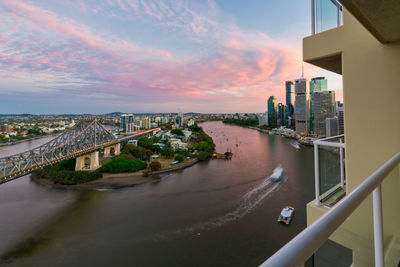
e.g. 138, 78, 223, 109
31, 158, 199, 190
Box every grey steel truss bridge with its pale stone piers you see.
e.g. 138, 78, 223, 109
0, 119, 161, 184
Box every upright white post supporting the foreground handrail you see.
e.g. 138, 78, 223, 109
372, 185, 385, 267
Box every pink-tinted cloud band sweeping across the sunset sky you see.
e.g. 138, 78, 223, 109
0, 0, 340, 112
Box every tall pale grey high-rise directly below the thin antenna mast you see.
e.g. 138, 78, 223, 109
294, 78, 310, 134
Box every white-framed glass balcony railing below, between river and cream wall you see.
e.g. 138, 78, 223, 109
314, 135, 346, 207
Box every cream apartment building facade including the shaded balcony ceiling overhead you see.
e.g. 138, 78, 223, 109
303, 3, 400, 267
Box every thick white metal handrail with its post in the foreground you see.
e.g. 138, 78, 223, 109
260, 152, 400, 267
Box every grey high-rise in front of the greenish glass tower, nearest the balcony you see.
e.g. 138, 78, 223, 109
314, 91, 336, 136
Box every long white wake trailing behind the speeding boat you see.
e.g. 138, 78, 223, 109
154, 173, 287, 240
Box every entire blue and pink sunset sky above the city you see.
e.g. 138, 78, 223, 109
0, 0, 342, 114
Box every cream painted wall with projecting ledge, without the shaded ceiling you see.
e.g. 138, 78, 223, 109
303, 7, 400, 264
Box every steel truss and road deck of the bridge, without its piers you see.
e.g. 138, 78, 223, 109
0, 120, 161, 184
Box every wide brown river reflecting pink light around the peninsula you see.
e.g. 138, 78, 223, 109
0, 122, 314, 266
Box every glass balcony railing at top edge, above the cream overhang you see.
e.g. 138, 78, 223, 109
311, 0, 342, 34
